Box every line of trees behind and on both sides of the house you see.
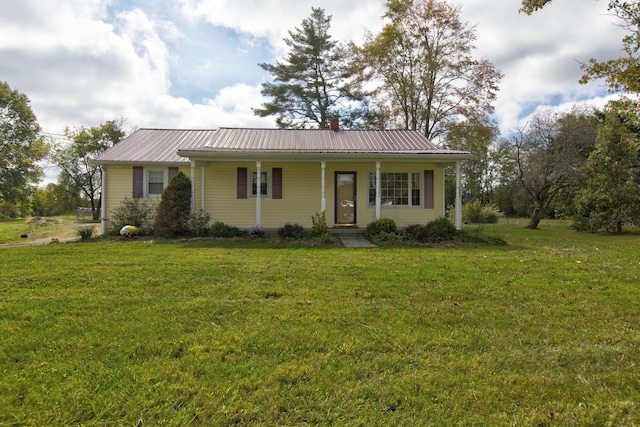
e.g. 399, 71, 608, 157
0, 0, 640, 231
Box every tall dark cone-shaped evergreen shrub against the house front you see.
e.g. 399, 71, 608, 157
153, 172, 191, 236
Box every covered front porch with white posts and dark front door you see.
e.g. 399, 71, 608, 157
189, 153, 462, 229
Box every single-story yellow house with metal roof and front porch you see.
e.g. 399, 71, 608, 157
95, 121, 471, 236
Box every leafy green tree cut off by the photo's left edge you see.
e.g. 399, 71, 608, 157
0, 82, 48, 216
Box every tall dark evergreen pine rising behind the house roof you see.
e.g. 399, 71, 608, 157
254, 8, 362, 129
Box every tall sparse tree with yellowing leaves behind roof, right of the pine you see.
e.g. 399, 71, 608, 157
353, 0, 502, 140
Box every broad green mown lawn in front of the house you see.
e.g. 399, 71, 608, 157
0, 224, 640, 426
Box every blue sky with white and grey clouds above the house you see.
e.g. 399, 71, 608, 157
0, 0, 622, 142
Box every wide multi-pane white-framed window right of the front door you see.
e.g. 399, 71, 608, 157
369, 172, 422, 207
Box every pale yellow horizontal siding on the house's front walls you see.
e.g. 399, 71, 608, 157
104, 162, 444, 232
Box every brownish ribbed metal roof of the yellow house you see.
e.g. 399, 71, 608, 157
96, 128, 470, 164
